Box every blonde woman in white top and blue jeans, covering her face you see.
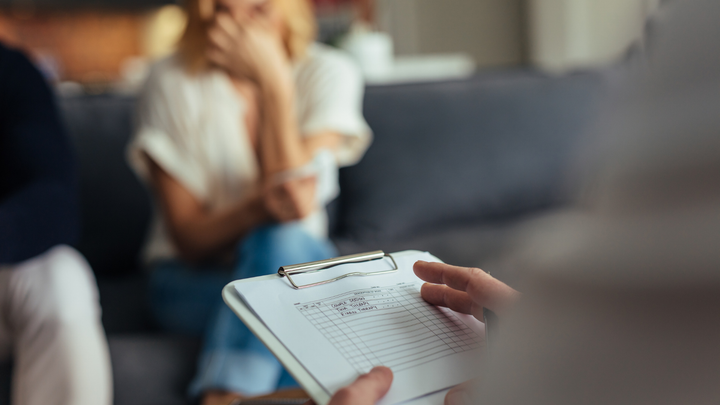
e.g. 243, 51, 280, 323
129, 0, 371, 404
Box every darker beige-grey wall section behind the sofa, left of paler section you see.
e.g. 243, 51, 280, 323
376, 0, 526, 67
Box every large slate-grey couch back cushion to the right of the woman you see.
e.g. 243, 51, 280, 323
338, 71, 602, 242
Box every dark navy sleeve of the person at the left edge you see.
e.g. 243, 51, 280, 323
0, 45, 79, 264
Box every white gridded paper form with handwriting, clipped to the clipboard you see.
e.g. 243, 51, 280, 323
235, 251, 483, 405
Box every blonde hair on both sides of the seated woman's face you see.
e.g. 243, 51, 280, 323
178, 0, 317, 72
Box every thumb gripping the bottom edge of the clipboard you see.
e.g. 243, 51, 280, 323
328, 367, 393, 405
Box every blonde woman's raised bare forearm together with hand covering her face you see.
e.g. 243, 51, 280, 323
207, 6, 312, 177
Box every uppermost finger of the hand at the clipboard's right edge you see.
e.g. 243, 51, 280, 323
413, 261, 520, 313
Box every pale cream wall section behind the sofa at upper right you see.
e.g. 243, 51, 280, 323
528, 0, 658, 72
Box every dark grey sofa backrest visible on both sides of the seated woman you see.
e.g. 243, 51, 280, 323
60, 71, 602, 274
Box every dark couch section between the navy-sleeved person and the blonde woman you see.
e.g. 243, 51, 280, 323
60, 95, 150, 275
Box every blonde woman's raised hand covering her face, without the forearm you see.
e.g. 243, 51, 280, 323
207, 12, 292, 86
